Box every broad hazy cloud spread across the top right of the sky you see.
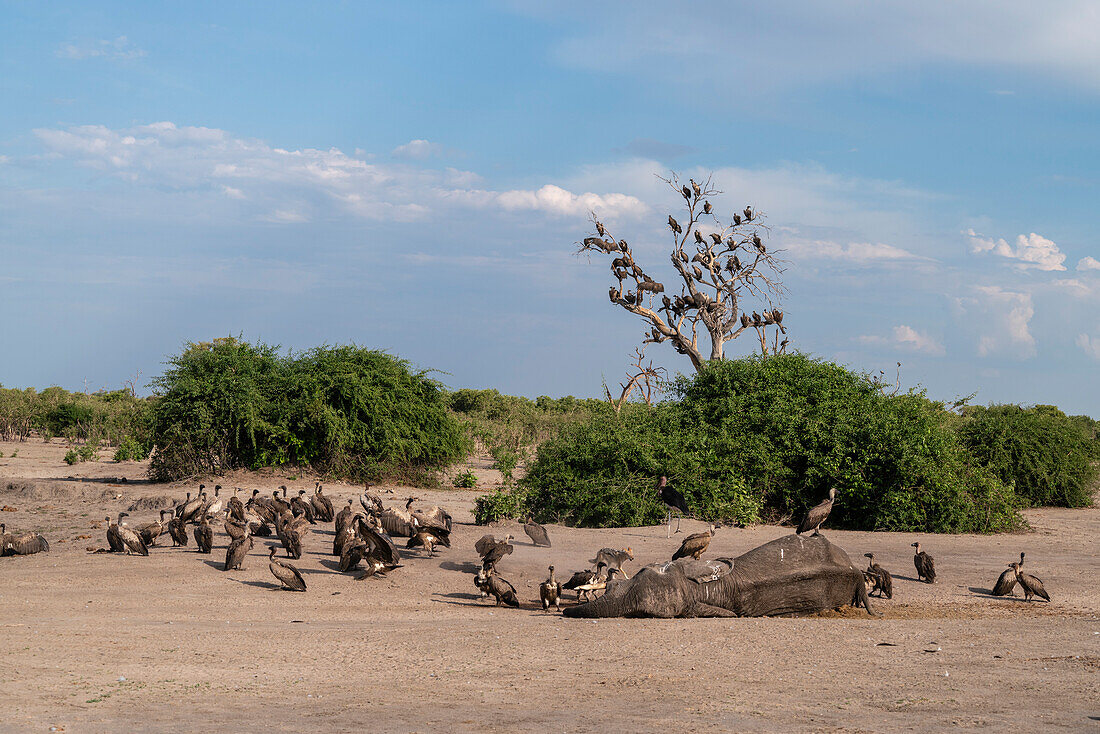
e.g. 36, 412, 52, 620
536, 0, 1100, 93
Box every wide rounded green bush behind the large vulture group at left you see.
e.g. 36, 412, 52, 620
150, 338, 470, 483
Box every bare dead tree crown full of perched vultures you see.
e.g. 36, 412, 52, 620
579, 174, 788, 370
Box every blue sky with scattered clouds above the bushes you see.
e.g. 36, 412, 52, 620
0, 0, 1100, 417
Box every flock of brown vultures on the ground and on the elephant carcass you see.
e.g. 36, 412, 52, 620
0, 476, 1051, 611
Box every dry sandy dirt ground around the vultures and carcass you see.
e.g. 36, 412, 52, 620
0, 441, 1100, 732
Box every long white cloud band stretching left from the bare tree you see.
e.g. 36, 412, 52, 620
35, 122, 646, 222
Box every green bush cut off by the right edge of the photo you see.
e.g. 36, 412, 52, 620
957, 405, 1097, 507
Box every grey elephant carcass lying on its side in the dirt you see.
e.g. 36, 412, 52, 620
564, 535, 871, 617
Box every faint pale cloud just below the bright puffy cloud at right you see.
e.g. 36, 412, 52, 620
958, 285, 1035, 358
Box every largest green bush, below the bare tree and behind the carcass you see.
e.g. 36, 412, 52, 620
486, 354, 1022, 533
